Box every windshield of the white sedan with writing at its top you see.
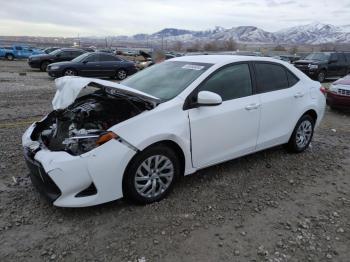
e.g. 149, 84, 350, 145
122, 61, 212, 101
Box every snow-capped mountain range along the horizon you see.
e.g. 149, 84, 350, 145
130, 23, 350, 44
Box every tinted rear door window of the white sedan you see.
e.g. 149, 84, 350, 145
255, 63, 289, 93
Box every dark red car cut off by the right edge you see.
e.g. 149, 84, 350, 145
326, 75, 350, 108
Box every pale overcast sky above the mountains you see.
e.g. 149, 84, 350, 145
0, 0, 350, 36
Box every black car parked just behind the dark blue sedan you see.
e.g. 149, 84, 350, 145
28, 48, 85, 71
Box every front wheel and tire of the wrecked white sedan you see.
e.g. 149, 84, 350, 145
123, 145, 181, 204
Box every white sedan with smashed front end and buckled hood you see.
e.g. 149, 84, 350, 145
22, 55, 325, 207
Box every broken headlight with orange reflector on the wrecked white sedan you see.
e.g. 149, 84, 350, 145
62, 131, 118, 155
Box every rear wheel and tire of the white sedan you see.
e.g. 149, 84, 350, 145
287, 115, 315, 153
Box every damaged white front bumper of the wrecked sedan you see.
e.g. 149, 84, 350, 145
22, 124, 136, 207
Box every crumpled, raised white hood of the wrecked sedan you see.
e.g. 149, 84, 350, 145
52, 76, 160, 110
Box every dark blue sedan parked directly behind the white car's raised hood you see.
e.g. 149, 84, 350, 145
47, 52, 137, 80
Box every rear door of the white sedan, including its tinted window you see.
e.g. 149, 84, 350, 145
254, 62, 307, 150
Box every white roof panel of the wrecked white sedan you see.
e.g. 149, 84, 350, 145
171, 55, 285, 64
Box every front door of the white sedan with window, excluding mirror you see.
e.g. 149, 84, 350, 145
188, 63, 260, 168
